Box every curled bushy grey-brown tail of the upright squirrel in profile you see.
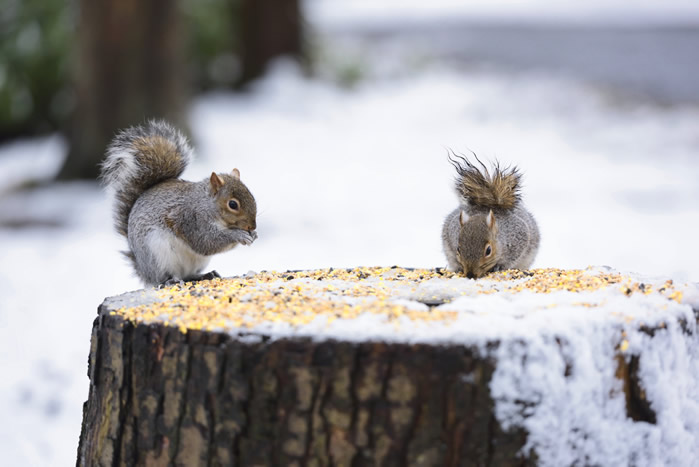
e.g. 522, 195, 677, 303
101, 120, 192, 236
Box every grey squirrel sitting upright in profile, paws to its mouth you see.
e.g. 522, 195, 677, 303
101, 120, 257, 286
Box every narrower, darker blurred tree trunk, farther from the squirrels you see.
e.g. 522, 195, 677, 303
240, 0, 303, 84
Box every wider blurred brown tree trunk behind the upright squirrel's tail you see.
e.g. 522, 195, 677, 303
58, 0, 187, 179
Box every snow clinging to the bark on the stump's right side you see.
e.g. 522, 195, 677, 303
490, 292, 699, 466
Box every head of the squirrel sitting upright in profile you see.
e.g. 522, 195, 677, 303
210, 169, 257, 232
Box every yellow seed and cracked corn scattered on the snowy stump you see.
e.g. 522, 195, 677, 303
114, 267, 682, 332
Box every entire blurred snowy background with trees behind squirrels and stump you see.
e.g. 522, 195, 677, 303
0, 0, 699, 465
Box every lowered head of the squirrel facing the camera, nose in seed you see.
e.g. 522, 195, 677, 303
456, 210, 498, 279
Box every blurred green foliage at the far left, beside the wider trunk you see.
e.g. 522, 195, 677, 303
0, 0, 75, 140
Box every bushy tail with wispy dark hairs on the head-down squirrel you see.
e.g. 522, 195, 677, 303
449, 152, 522, 209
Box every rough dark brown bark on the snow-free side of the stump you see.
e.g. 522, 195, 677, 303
78, 305, 536, 466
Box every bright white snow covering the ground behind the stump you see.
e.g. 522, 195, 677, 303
0, 33, 699, 465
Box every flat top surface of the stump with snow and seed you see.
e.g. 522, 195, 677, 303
103, 267, 699, 342
